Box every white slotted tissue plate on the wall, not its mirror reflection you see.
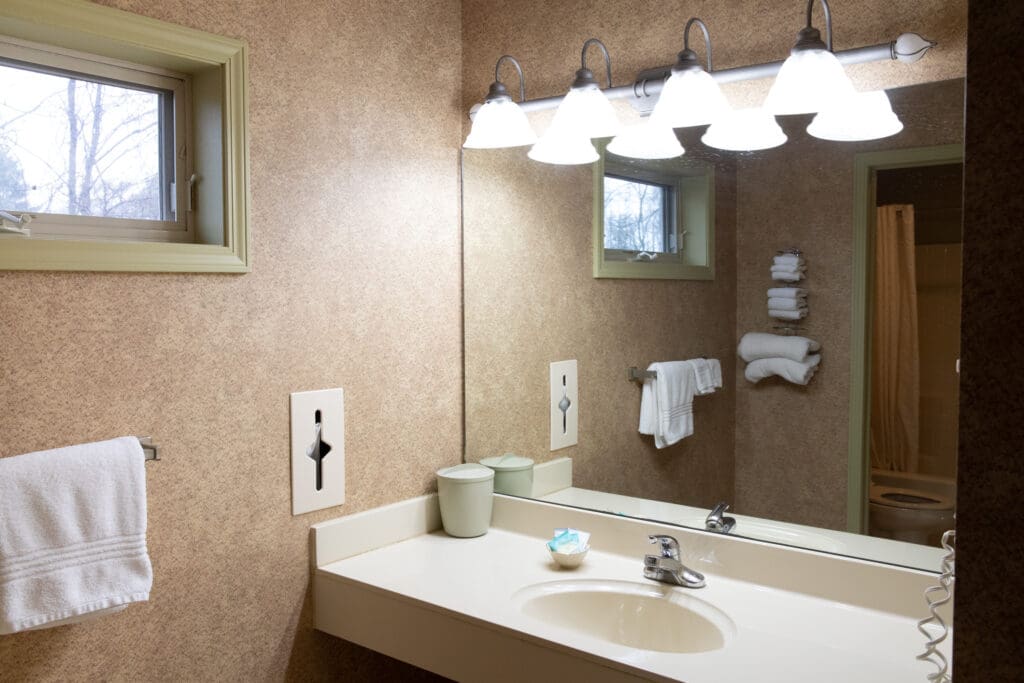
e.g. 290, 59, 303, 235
291, 389, 345, 515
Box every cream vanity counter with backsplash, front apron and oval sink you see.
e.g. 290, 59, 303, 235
312, 496, 949, 683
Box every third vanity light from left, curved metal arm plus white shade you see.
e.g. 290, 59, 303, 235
650, 16, 729, 128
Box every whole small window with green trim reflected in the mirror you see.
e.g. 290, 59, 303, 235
594, 145, 715, 280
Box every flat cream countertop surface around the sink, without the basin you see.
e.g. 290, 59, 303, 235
316, 501, 950, 683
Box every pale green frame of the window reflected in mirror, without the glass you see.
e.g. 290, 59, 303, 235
593, 140, 715, 280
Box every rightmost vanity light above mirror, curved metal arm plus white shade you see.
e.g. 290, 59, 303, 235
764, 0, 854, 115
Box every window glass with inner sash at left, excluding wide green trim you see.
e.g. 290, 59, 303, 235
0, 38, 195, 242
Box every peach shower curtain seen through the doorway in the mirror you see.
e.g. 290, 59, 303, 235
870, 204, 921, 472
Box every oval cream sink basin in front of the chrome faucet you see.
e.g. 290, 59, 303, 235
513, 580, 736, 653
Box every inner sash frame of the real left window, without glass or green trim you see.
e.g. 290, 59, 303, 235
0, 35, 196, 243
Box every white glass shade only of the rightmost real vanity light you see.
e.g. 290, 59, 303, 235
764, 49, 854, 116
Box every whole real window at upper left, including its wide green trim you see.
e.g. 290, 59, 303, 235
0, 0, 249, 272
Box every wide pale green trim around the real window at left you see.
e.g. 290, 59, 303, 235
0, 0, 250, 272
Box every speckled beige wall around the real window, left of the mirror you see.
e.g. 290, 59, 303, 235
0, 0, 462, 681
